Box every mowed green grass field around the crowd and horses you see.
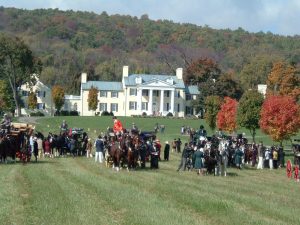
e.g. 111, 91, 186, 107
0, 117, 300, 225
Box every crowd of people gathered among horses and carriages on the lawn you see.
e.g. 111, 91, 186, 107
1, 115, 296, 178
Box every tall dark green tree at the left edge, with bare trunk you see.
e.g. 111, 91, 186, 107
0, 33, 42, 115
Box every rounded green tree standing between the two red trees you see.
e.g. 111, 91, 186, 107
237, 90, 264, 142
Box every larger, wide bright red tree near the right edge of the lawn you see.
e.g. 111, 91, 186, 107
259, 95, 300, 144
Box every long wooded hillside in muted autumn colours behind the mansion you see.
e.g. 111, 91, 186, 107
0, 7, 300, 93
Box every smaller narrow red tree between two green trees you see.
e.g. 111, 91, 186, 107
217, 97, 238, 133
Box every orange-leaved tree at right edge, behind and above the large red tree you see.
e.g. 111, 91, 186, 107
267, 62, 300, 100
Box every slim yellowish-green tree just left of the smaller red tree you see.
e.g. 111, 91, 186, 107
204, 96, 222, 131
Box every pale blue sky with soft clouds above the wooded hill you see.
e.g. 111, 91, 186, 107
0, 0, 300, 35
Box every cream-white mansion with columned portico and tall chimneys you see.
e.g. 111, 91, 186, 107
21, 66, 200, 117
